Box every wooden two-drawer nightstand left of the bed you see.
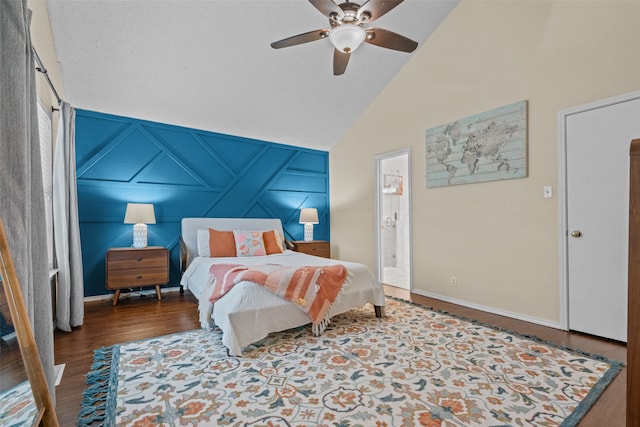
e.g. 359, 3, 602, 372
106, 246, 169, 305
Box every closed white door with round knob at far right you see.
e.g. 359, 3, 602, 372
565, 95, 640, 341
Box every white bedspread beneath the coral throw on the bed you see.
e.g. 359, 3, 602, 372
180, 251, 385, 356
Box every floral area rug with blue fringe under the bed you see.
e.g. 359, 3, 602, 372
79, 298, 621, 427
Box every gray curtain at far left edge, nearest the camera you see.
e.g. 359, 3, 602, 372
0, 0, 55, 398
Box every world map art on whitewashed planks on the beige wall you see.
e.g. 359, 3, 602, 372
425, 101, 527, 188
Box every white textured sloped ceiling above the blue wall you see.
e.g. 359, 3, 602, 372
47, 0, 457, 150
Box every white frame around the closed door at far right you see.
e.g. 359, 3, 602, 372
558, 91, 640, 331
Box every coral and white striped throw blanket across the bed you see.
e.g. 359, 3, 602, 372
209, 264, 348, 335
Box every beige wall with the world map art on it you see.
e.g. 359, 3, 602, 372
330, 0, 640, 323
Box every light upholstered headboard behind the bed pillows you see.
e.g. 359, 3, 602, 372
180, 218, 283, 271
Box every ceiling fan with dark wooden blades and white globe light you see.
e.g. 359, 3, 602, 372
271, 0, 418, 76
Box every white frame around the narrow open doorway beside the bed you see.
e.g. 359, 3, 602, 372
374, 147, 413, 291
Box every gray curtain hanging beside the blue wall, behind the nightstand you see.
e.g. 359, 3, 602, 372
53, 102, 84, 332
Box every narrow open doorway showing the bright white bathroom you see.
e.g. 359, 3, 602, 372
376, 149, 411, 290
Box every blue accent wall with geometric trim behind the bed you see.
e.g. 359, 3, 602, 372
76, 110, 329, 296
